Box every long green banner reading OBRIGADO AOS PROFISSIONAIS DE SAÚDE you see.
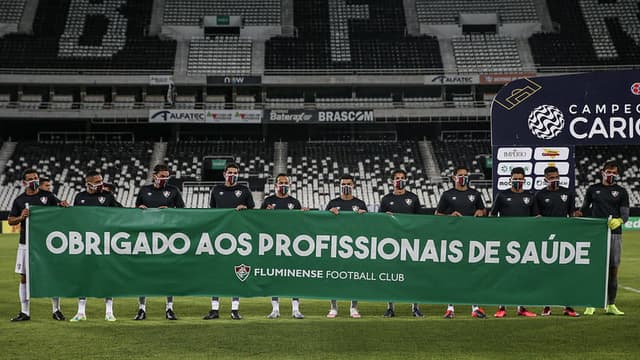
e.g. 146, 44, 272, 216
28, 207, 608, 306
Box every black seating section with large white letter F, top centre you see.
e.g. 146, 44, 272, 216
265, 0, 442, 73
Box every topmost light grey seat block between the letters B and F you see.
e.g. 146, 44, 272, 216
164, 0, 281, 26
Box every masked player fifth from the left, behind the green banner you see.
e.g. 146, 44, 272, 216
260, 174, 309, 319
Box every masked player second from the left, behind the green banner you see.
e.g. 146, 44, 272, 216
70, 170, 122, 322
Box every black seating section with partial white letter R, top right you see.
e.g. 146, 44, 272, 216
529, 0, 640, 71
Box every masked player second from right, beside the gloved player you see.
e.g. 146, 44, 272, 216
534, 166, 580, 317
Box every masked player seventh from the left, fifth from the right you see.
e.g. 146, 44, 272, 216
378, 169, 423, 317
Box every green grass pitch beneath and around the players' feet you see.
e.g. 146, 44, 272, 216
0, 232, 640, 360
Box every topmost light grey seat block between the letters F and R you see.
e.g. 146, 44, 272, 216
416, 0, 538, 24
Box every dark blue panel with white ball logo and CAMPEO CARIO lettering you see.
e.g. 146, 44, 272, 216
491, 70, 640, 146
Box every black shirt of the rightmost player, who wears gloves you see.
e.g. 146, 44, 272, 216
582, 183, 629, 234
